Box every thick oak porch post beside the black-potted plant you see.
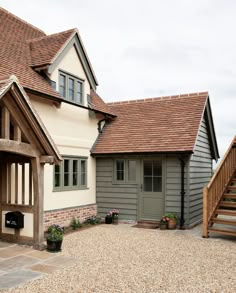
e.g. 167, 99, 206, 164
31, 158, 44, 250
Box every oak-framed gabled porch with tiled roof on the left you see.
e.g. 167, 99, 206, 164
0, 76, 62, 248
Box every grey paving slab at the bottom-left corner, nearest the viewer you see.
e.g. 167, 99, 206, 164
0, 270, 42, 289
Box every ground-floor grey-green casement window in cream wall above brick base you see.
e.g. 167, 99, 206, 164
54, 157, 87, 191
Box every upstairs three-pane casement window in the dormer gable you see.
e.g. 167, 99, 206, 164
59, 71, 83, 105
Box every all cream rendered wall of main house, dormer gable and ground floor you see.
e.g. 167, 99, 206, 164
31, 41, 98, 211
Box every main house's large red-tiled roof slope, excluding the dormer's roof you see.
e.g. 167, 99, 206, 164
0, 8, 61, 98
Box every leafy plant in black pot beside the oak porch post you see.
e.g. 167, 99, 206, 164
47, 224, 64, 252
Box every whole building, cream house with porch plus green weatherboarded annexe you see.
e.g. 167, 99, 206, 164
0, 8, 218, 247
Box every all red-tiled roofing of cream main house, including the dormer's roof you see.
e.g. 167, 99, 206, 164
0, 7, 113, 115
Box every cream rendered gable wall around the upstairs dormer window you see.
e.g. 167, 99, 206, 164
49, 46, 90, 106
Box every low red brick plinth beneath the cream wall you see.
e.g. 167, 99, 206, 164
44, 204, 97, 231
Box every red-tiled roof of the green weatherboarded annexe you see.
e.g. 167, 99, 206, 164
92, 92, 208, 154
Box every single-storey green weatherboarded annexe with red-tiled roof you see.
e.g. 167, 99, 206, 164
92, 92, 219, 227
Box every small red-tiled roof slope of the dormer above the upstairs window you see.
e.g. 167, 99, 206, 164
28, 29, 77, 67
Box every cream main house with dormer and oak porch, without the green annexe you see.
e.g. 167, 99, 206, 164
0, 8, 115, 246
